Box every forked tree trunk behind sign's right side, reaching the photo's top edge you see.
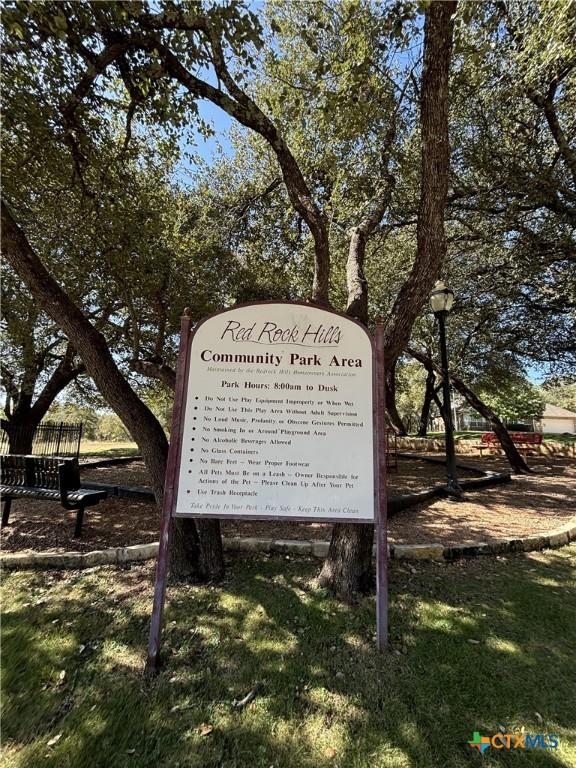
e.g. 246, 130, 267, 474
319, 2, 456, 600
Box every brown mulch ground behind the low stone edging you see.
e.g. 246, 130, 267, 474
2, 457, 576, 552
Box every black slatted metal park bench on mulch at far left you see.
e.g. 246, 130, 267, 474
0, 455, 107, 538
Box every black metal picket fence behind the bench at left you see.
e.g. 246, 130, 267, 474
0, 421, 82, 458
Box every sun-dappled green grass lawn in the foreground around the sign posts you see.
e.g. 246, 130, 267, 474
2, 545, 576, 768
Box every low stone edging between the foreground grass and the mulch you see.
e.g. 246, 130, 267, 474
0, 517, 576, 570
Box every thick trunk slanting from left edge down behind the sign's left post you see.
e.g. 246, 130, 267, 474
2, 201, 223, 575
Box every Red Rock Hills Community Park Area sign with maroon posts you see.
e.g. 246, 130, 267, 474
147, 302, 387, 669
